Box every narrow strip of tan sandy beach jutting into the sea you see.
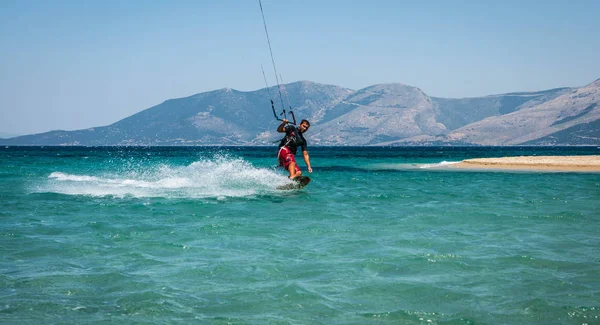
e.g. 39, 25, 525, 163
452, 156, 600, 172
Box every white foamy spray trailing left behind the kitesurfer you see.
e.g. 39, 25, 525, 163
37, 156, 290, 198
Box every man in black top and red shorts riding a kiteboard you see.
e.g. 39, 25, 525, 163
277, 119, 312, 179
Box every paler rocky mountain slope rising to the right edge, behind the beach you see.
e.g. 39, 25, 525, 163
396, 79, 600, 145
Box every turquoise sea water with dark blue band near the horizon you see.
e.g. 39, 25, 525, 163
0, 147, 600, 324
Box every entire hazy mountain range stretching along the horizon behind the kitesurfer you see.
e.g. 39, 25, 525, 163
0, 79, 600, 146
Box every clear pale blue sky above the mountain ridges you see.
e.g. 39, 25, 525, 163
0, 0, 600, 135
